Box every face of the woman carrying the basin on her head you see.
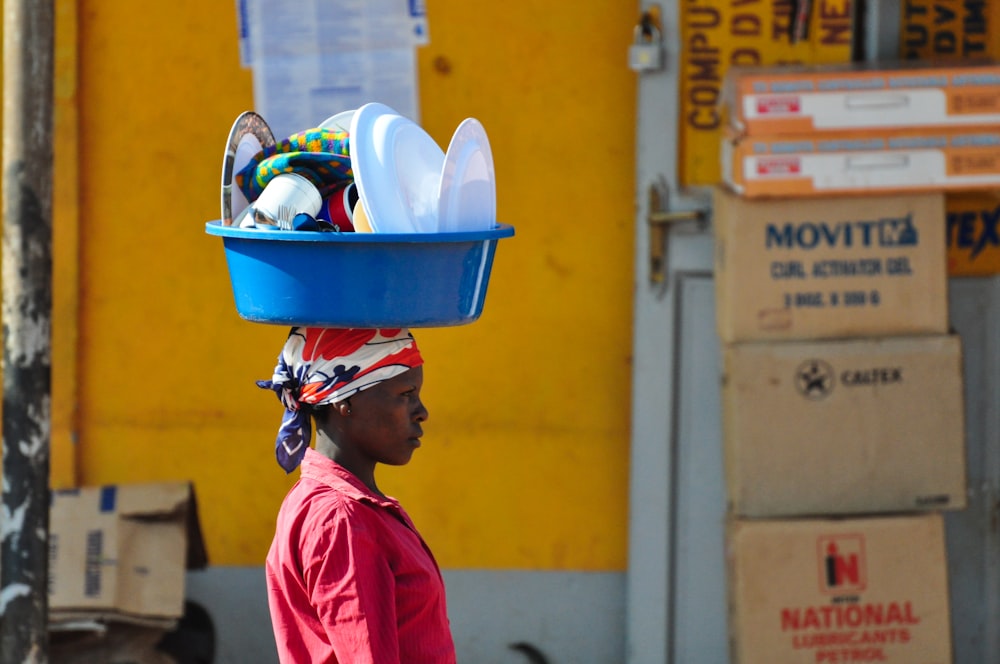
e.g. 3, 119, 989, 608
344, 366, 427, 466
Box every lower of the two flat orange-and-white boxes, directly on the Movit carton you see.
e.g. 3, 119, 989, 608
720, 125, 1000, 198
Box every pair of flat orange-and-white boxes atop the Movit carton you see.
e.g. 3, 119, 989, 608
721, 63, 1000, 197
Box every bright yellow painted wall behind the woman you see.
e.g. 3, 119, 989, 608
53, 0, 637, 570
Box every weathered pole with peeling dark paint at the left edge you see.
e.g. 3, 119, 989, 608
0, 0, 54, 663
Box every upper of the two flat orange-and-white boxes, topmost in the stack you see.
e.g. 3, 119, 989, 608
723, 62, 1000, 137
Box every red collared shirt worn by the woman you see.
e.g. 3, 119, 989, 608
266, 448, 455, 664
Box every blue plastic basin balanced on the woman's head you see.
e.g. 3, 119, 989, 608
205, 221, 514, 327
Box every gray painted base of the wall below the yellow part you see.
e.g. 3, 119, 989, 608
186, 566, 625, 664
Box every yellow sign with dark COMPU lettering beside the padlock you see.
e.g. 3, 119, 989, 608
677, 0, 854, 186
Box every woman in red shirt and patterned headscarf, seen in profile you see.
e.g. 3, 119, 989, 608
258, 327, 455, 664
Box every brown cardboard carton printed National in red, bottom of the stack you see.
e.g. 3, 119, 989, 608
727, 514, 952, 664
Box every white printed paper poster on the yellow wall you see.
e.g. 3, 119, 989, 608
237, 0, 428, 140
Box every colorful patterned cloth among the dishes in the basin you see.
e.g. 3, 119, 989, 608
233, 128, 354, 203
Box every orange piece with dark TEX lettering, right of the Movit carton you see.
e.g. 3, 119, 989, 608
945, 192, 1000, 277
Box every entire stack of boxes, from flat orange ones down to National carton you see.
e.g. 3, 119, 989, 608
714, 63, 1000, 664
